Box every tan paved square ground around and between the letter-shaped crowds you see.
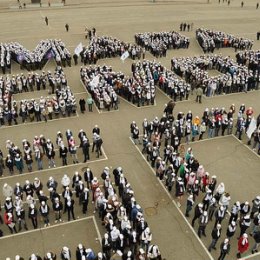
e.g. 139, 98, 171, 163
0, 0, 260, 260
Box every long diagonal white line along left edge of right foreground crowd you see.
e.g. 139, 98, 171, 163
129, 137, 214, 260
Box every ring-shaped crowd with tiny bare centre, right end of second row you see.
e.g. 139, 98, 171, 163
171, 55, 260, 97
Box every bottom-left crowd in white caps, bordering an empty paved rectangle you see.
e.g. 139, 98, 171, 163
0, 167, 161, 260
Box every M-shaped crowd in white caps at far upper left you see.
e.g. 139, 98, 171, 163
0, 39, 71, 74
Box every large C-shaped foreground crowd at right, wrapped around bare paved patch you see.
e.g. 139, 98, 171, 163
130, 104, 260, 260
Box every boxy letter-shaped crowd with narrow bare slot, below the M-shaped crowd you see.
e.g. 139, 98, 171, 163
0, 66, 77, 126
